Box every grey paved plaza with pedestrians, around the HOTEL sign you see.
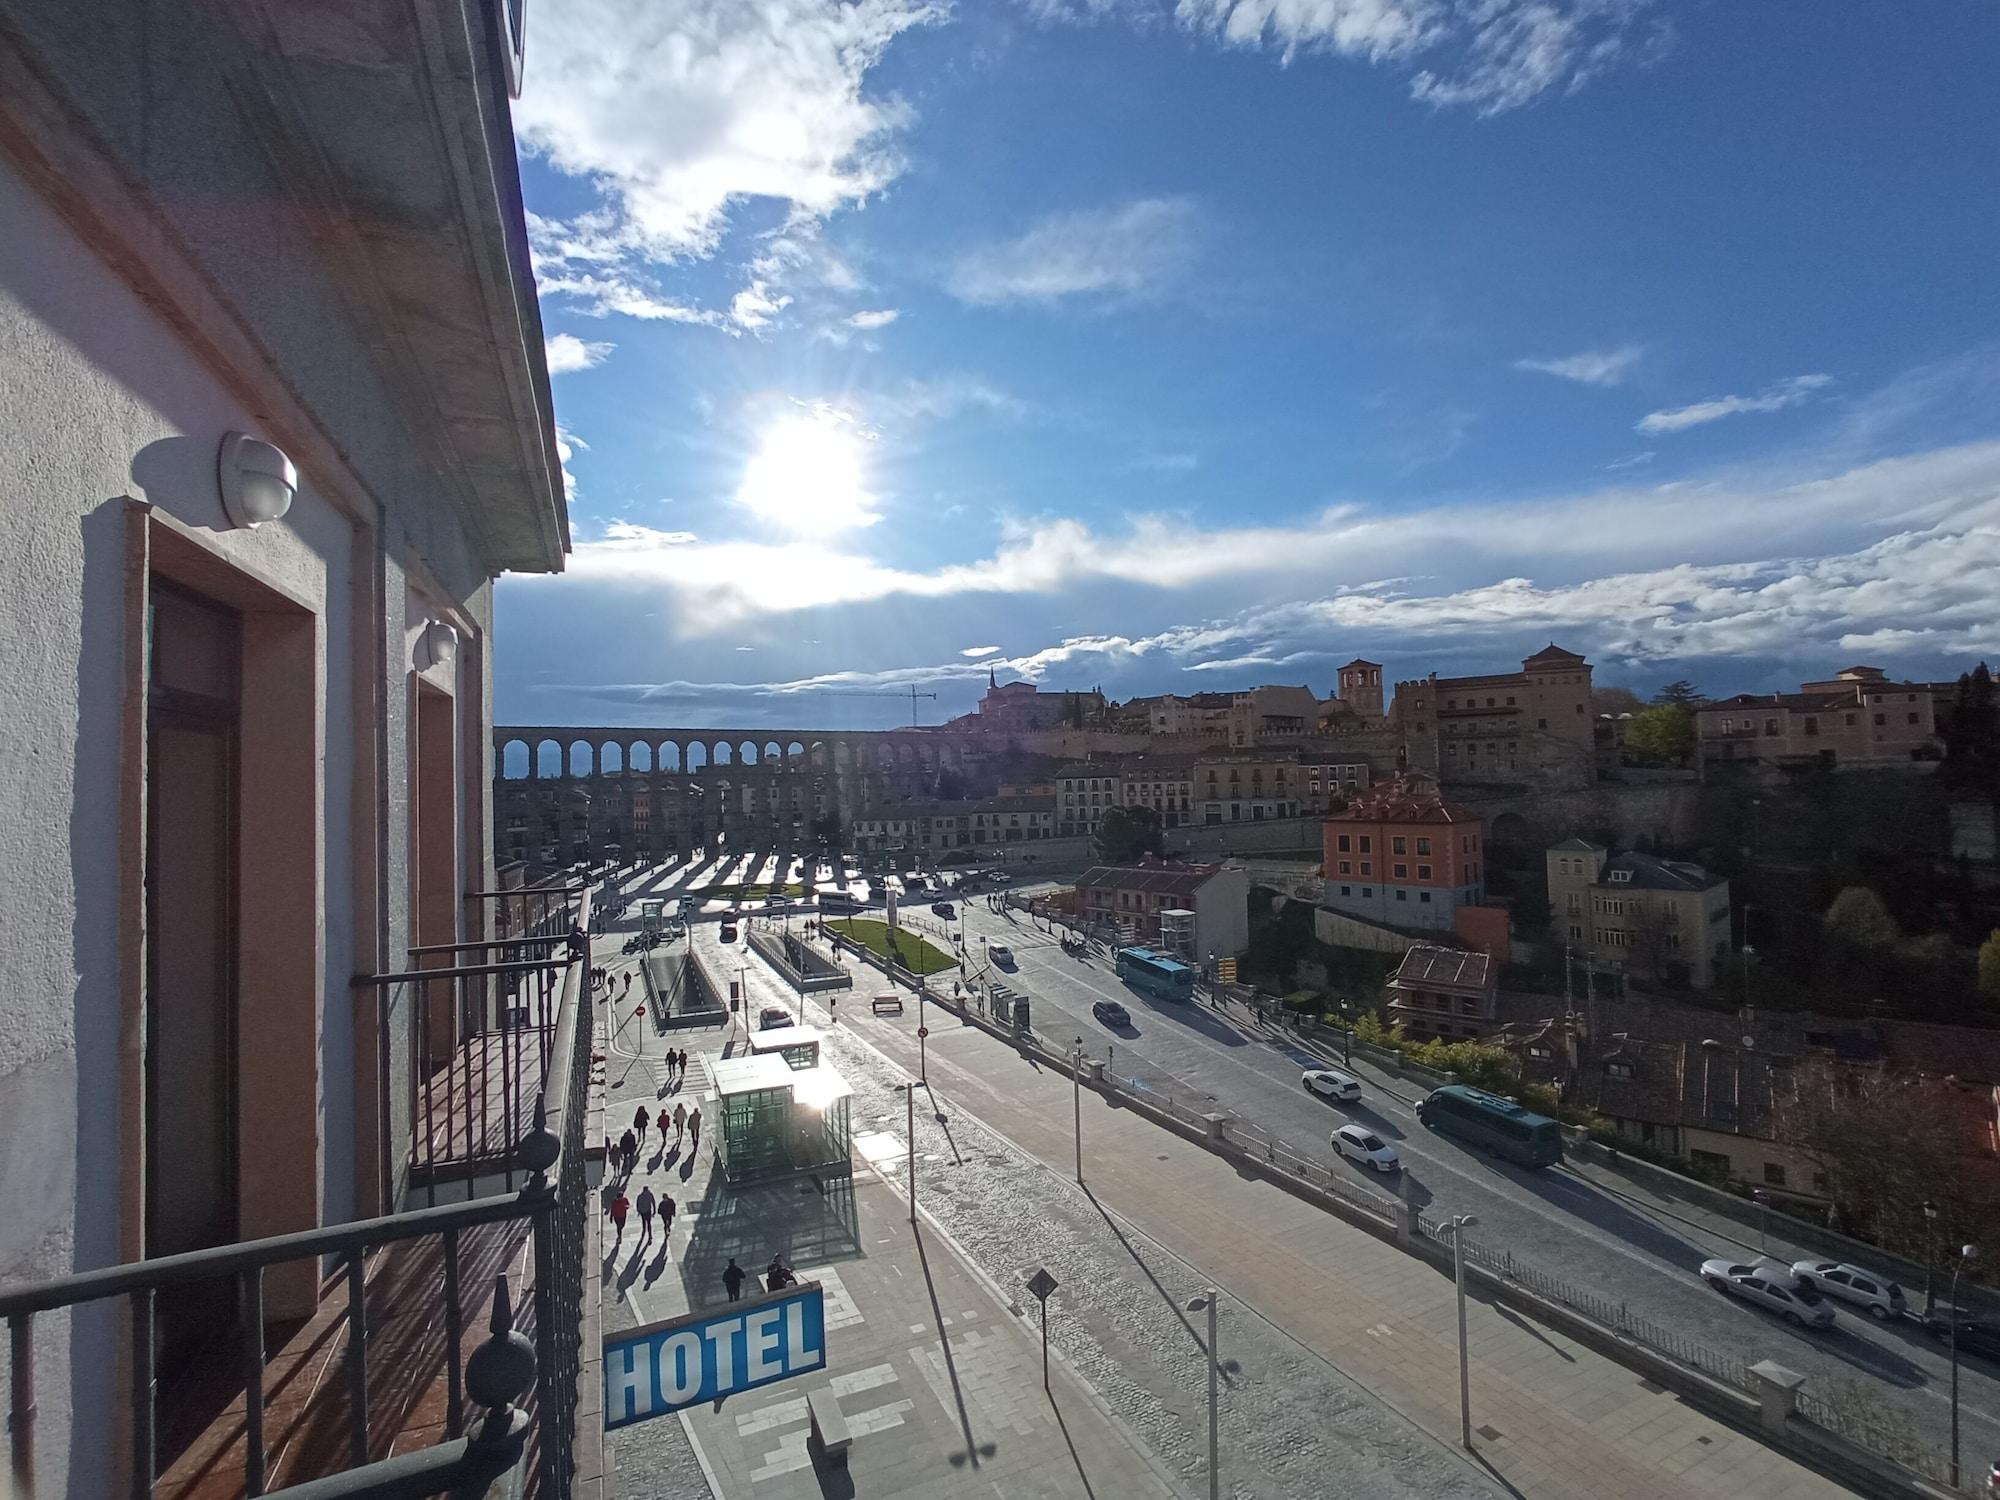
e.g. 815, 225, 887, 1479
604, 1016, 1176, 1500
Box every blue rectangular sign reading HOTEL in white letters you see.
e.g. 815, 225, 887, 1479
604, 1282, 826, 1430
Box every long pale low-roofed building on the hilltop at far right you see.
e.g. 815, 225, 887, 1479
1694, 666, 1944, 766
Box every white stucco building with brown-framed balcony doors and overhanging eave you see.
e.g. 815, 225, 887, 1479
0, 0, 572, 1500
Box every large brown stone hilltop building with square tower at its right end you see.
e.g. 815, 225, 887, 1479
1390, 642, 1596, 786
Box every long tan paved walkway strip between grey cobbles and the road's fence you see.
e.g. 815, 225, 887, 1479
824, 988, 1848, 1500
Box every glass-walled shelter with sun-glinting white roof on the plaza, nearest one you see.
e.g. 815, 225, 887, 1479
714, 1028, 852, 1182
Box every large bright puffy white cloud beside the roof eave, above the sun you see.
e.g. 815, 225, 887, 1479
514, 0, 946, 314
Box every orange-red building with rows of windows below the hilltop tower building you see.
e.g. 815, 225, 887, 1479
1322, 776, 1486, 932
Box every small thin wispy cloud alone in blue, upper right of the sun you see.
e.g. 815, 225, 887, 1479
946, 198, 1200, 306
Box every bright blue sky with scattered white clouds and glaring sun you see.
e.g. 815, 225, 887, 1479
496, 0, 2000, 728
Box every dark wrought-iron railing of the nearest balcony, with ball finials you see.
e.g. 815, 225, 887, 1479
0, 892, 592, 1500
